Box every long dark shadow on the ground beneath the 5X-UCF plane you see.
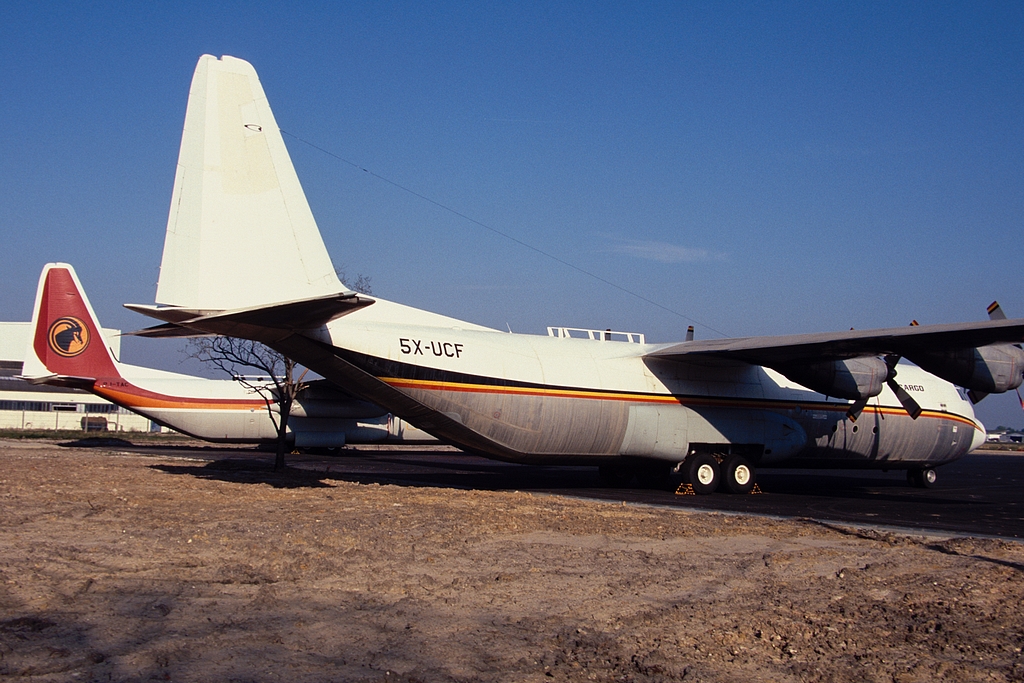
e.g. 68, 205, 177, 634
142, 453, 1024, 540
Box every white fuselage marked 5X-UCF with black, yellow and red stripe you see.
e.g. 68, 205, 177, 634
268, 300, 984, 469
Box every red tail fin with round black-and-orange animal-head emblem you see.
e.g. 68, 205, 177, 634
22, 263, 121, 386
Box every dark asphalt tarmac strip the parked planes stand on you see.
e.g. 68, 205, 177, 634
99, 446, 1024, 539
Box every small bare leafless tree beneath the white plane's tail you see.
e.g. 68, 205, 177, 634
185, 336, 306, 470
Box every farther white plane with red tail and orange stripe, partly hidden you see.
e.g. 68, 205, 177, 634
22, 263, 433, 449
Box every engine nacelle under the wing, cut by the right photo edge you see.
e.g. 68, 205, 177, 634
906, 344, 1024, 393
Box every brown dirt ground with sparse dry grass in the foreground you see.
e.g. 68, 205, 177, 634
0, 441, 1024, 682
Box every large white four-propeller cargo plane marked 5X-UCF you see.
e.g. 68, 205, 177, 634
132, 55, 1024, 494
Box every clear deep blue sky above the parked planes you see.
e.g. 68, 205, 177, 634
6, 2, 1024, 425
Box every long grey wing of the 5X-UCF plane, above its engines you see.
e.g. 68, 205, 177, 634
645, 318, 1024, 367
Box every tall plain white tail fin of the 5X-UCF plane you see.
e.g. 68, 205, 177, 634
157, 54, 345, 310
